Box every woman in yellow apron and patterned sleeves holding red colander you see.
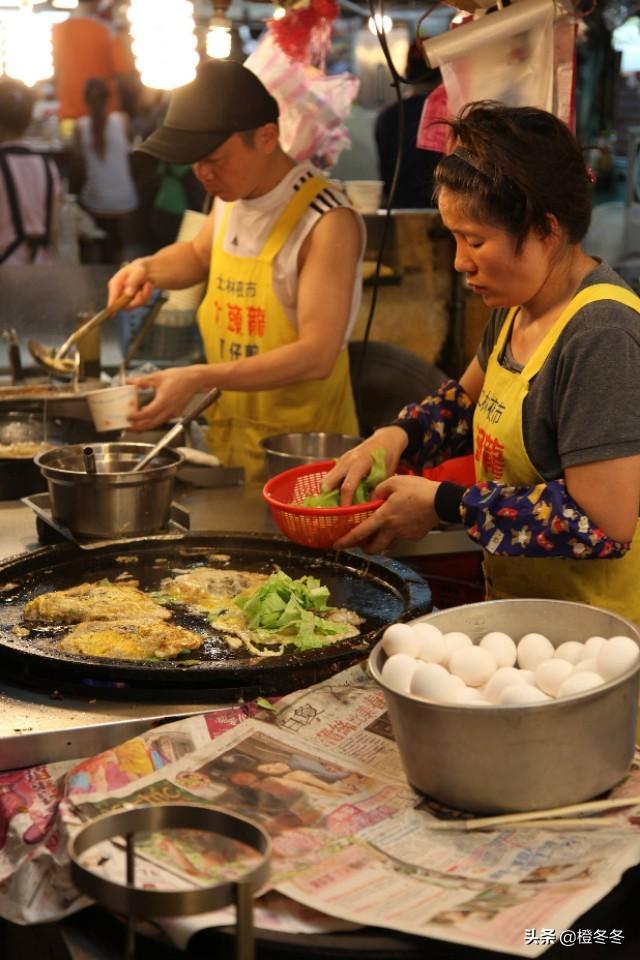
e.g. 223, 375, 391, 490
325, 102, 640, 621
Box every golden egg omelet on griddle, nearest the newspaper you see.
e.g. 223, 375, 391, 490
60, 620, 204, 660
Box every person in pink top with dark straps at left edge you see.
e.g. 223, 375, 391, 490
0, 77, 60, 266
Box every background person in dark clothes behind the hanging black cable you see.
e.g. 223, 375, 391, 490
375, 41, 441, 209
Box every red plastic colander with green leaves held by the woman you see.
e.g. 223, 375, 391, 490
262, 460, 384, 549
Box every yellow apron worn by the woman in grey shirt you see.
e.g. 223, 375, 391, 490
473, 283, 640, 624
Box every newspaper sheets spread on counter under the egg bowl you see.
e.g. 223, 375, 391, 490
0, 667, 640, 957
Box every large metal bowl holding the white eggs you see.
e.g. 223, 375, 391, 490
369, 600, 640, 813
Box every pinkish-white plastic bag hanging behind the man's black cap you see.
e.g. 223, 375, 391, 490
244, 34, 360, 169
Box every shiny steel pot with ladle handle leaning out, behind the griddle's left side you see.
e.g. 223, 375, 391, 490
35, 442, 183, 540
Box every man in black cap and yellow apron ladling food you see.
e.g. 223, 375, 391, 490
109, 60, 364, 479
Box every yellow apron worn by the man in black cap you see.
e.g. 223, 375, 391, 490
198, 177, 358, 482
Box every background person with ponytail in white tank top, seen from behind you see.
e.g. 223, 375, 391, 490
74, 77, 138, 263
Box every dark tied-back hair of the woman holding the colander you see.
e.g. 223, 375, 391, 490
434, 100, 591, 248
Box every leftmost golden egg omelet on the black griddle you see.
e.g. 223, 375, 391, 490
23, 580, 171, 624
